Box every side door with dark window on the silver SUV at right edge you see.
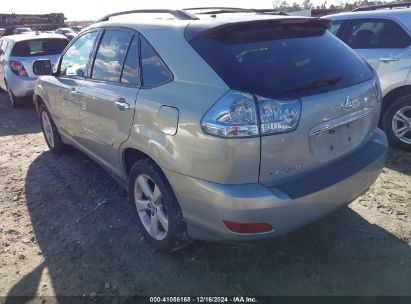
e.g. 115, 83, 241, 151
343, 18, 411, 92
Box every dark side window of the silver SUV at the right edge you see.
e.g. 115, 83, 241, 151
344, 19, 406, 49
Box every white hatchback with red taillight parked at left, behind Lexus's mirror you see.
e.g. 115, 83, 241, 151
0, 34, 69, 107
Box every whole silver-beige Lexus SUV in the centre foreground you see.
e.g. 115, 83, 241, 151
33, 10, 387, 250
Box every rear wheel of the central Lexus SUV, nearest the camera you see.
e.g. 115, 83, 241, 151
129, 158, 187, 252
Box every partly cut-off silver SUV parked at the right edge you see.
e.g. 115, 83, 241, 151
324, 4, 411, 151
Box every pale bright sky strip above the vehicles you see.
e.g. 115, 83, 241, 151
0, 0, 347, 21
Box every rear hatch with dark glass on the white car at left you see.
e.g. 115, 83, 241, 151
9, 38, 69, 77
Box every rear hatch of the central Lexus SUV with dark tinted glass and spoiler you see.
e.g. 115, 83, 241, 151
186, 18, 380, 185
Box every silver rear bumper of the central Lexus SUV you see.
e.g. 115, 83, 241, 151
164, 130, 388, 241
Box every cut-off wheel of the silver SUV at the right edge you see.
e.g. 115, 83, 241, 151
382, 94, 411, 152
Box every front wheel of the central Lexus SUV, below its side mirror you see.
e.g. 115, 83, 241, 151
39, 103, 70, 153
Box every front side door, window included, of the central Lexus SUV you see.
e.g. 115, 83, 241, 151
47, 30, 99, 139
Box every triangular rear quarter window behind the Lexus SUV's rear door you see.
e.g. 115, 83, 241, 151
141, 39, 173, 87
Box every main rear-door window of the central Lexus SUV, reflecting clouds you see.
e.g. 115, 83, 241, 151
91, 30, 133, 82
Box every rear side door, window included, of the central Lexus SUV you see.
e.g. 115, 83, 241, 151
79, 28, 140, 177
